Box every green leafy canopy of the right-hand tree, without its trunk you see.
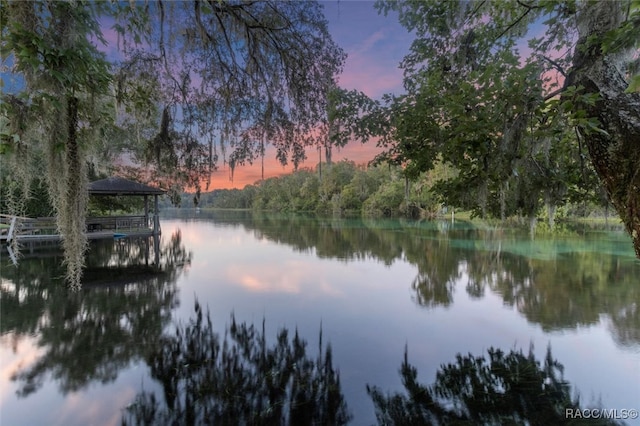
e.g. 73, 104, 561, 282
320, 0, 637, 226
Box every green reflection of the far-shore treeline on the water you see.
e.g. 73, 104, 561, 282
184, 212, 640, 346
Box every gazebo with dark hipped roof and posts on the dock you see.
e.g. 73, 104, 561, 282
88, 176, 166, 235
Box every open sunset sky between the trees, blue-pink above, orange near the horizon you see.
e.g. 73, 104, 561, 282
210, 0, 413, 189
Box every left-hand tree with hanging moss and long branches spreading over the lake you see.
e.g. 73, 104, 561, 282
0, 0, 345, 285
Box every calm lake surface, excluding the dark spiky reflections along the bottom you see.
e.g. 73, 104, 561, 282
0, 212, 640, 426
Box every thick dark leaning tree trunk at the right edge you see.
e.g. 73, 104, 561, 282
566, 1, 640, 259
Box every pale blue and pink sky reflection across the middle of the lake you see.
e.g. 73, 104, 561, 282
164, 222, 640, 424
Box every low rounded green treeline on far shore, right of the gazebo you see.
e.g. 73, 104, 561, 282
191, 160, 609, 223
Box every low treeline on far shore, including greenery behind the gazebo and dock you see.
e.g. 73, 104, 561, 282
0, 160, 615, 225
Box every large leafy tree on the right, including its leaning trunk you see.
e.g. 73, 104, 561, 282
377, 0, 640, 257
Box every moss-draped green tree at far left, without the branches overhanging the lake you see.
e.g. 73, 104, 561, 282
0, 1, 110, 285
